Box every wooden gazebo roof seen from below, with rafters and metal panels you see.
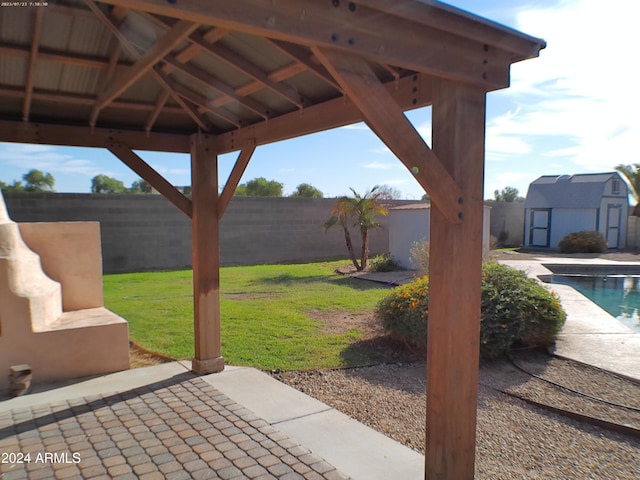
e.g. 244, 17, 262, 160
0, 0, 544, 151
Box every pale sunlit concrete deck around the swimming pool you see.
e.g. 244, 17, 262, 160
500, 256, 640, 380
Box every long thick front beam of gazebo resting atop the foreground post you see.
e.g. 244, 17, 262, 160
99, 0, 528, 91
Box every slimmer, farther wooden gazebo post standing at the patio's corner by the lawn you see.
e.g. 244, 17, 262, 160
191, 134, 224, 375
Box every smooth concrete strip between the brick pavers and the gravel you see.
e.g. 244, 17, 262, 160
203, 367, 425, 480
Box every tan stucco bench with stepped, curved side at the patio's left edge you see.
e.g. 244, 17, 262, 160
0, 193, 129, 393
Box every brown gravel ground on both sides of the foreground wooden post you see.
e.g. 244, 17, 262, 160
277, 352, 640, 480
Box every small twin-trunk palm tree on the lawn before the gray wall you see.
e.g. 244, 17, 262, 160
324, 186, 388, 271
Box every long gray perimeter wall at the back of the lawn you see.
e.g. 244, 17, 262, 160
4, 192, 415, 273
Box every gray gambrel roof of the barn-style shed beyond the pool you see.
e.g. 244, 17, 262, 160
524, 172, 628, 209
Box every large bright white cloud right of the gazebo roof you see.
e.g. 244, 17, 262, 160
487, 0, 640, 173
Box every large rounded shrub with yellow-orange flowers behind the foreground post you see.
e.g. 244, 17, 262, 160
377, 263, 566, 358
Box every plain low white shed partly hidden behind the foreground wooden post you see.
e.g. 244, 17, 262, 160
389, 203, 491, 270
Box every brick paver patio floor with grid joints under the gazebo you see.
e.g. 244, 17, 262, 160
0, 373, 347, 480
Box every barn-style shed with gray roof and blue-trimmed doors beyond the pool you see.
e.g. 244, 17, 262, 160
524, 172, 629, 249
